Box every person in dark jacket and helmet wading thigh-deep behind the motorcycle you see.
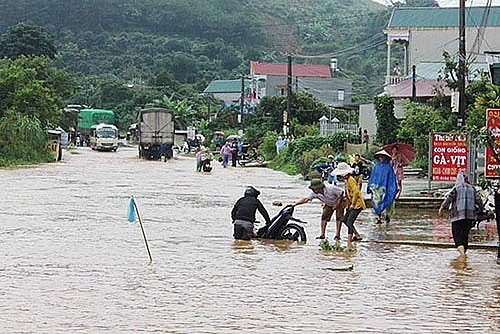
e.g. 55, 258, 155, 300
231, 186, 271, 240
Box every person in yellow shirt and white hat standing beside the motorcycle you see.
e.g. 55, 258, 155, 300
333, 162, 366, 249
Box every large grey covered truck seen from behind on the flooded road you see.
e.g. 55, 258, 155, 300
138, 108, 174, 160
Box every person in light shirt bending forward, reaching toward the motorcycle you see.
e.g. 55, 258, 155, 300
293, 179, 344, 239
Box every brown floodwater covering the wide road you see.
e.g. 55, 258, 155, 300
0, 148, 500, 333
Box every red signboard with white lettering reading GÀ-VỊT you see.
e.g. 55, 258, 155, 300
431, 133, 469, 181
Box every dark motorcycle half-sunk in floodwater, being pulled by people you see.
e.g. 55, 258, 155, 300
255, 205, 307, 243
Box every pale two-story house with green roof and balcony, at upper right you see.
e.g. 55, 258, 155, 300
360, 7, 500, 141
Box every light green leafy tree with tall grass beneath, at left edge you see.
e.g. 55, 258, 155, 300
0, 56, 74, 165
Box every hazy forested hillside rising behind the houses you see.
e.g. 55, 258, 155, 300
0, 0, 389, 101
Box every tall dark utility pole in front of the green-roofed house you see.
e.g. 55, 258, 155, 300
457, 0, 465, 129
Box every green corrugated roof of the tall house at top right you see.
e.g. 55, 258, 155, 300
387, 7, 500, 28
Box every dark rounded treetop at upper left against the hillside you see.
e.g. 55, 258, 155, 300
0, 22, 56, 59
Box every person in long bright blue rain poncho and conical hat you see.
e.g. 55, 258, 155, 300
366, 150, 398, 224
